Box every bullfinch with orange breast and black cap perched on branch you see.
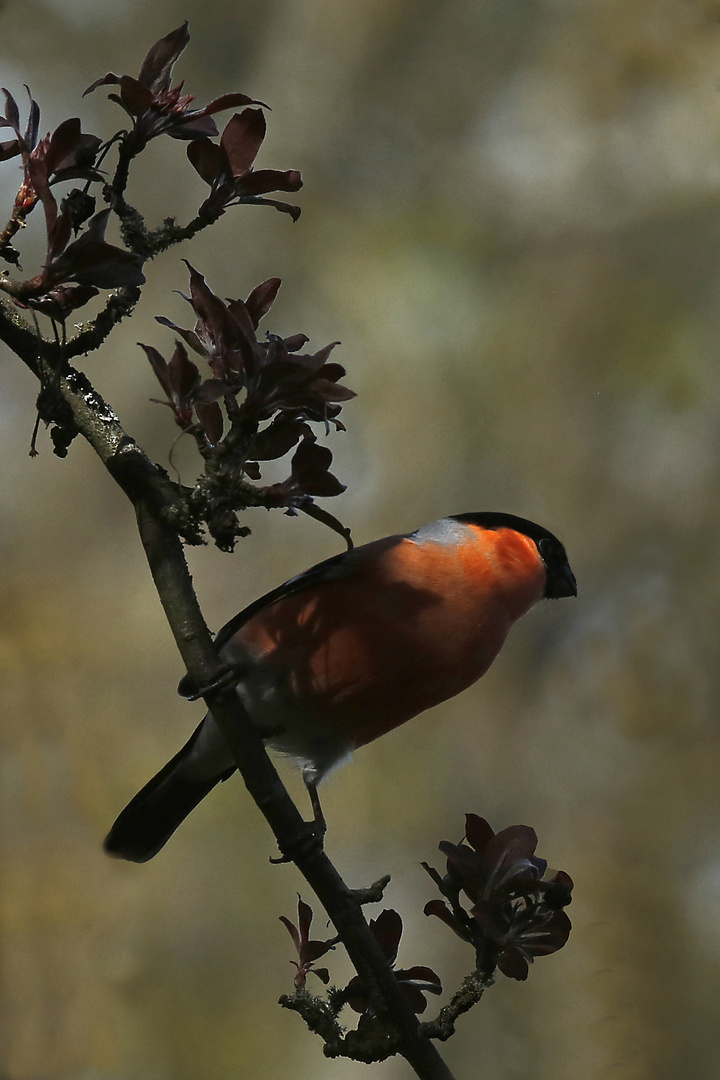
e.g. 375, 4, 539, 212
105, 511, 578, 863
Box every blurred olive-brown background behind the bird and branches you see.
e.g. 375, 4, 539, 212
0, 0, 720, 1080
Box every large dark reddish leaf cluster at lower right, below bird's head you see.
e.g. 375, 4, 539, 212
423, 813, 572, 980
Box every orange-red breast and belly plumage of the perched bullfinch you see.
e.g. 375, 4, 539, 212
236, 527, 544, 746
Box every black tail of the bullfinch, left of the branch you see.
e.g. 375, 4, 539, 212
104, 732, 235, 863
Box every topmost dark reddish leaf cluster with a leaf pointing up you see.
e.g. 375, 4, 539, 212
83, 22, 262, 157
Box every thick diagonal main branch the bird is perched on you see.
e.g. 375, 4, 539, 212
0, 307, 452, 1080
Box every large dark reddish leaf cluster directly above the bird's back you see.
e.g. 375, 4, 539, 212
142, 264, 355, 508
